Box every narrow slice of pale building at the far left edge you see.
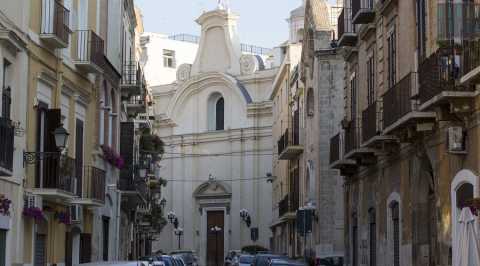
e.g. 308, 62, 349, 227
0, 1, 29, 266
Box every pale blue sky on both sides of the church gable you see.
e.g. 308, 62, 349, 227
135, 0, 338, 48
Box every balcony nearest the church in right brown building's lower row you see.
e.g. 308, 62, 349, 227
330, 133, 358, 176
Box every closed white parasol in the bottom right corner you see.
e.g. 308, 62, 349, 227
453, 208, 480, 266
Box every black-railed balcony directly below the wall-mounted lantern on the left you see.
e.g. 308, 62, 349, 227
33, 156, 76, 203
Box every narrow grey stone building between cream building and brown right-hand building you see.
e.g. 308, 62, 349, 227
300, 0, 345, 264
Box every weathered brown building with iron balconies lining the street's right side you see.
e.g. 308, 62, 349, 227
330, 0, 479, 266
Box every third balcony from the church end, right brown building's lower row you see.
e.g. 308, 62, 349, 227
361, 101, 396, 150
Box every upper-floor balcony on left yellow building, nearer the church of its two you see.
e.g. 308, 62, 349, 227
73, 30, 105, 74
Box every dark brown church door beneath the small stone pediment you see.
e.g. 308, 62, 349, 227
207, 211, 225, 266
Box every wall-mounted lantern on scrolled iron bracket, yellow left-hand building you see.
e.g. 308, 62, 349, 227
23, 125, 70, 164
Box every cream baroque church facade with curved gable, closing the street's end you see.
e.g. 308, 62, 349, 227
147, 7, 277, 265
